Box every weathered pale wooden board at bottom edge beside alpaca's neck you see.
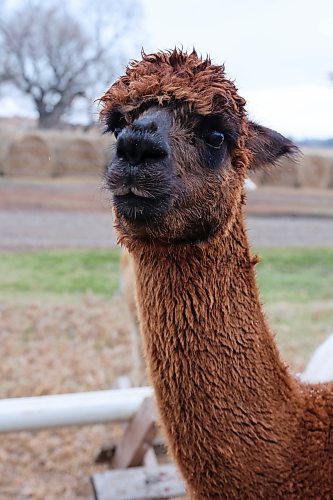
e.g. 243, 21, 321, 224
91, 464, 186, 500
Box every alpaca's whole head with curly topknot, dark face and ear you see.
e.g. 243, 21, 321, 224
101, 50, 294, 244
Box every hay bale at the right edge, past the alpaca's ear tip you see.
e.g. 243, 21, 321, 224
298, 155, 332, 189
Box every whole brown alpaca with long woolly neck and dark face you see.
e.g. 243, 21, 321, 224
101, 50, 333, 499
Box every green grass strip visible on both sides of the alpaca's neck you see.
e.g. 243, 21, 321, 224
0, 248, 333, 304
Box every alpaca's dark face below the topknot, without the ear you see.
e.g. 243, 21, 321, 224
106, 103, 241, 242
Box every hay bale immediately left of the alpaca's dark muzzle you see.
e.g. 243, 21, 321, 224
54, 135, 104, 176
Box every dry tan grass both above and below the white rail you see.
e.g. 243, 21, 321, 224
0, 295, 138, 500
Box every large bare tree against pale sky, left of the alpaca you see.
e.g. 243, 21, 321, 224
0, 0, 139, 128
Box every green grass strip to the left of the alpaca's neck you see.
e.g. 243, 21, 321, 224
0, 249, 120, 301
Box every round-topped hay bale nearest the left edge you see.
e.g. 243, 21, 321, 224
5, 134, 53, 177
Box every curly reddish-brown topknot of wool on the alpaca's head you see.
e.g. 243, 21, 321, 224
100, 49, 245, 125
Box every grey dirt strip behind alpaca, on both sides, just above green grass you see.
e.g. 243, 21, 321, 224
0, 209, 333, 251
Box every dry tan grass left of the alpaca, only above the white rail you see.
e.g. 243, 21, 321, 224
0, 295, 135, 397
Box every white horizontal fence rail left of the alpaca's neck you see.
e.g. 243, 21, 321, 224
0, 387, 153, 433
